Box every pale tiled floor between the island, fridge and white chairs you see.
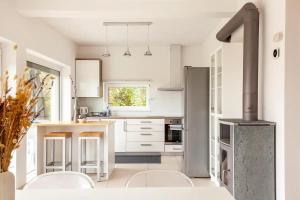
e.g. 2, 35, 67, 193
91, 156, 216, 189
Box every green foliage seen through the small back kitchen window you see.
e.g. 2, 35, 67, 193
108, 87, 147, 106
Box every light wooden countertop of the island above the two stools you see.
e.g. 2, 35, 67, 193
34, 120, 115, 127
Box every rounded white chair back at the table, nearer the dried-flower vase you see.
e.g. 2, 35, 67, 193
23, 171, 95, 190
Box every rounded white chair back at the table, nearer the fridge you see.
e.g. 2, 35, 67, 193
126, 170, 194, 188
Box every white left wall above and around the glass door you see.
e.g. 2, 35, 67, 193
0, 0, 76, 187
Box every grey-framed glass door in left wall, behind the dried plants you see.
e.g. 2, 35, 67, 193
26, 62, 60, 182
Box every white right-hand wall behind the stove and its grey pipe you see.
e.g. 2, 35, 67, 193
200, 0, 285, 200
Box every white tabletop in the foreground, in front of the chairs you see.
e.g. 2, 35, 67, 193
16, 187, 234, 200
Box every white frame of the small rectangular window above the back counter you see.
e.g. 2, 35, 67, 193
103, 81, 151, 112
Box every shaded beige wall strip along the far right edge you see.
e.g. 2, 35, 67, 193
284, 0, 300, 200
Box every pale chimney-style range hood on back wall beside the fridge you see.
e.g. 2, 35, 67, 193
158, 44, 183, 92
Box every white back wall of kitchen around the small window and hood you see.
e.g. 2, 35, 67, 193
77, 46, 183, 116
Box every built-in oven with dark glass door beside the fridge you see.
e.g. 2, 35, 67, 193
165, 118, 183, 145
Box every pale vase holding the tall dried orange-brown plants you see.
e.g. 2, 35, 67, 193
0, 172, 16, 200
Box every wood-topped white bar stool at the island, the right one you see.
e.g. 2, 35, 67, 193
78, 132, 104, 181
